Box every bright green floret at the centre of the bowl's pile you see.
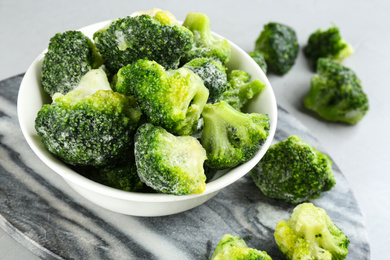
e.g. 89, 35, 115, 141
113, 60, 209, 135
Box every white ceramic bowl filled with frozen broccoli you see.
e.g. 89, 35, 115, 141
17, 21, 277, 216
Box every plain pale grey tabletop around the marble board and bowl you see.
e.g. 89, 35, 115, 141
0, 0, 390, 259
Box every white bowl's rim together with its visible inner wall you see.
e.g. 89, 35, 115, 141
17, 21, 277, 202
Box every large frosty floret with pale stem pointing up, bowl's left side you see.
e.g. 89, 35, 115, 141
35, 69, 141, 167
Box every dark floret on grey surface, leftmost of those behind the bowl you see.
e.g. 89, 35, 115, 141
255, 22, 299, 75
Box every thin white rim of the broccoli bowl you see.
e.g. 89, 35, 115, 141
17, 20, 277, 202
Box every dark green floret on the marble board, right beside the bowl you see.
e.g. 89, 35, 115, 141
251, 135, 336, 204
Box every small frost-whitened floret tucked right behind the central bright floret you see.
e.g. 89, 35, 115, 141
183, 58, 227, 103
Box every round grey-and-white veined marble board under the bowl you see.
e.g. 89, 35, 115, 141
0, 75, 370, 260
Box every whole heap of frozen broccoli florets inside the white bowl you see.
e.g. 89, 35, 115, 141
35, 9, 269, 195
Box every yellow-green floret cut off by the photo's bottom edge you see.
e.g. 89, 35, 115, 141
211, 234, 272, 260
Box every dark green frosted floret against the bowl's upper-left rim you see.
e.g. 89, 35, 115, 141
41, 31, 102, 96
